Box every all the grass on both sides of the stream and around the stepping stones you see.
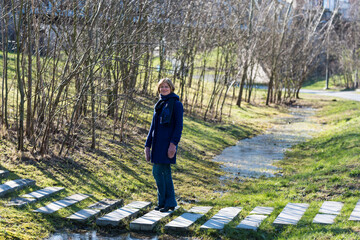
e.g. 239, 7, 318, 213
0, 93, 360, 239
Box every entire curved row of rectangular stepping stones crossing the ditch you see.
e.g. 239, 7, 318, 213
0, 170, 360, 231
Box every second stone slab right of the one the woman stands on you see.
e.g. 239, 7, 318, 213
200, 207, 242, 230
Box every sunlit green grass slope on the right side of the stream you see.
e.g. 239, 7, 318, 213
216, 96, 360, 239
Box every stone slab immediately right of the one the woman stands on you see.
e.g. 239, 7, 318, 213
165, 207, 212, 230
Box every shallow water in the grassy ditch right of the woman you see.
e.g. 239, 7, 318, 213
213, 107, 321, 180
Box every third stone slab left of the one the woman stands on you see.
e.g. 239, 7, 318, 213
33, 193, 90, 214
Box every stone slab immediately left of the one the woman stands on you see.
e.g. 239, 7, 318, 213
96, 201, 151, 226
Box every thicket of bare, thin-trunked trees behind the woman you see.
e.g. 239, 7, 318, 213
0, 0, 354, 156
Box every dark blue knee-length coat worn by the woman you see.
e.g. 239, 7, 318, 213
145, 93, 184, 164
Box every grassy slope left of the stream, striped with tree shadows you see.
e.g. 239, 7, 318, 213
0, 91, 281, 239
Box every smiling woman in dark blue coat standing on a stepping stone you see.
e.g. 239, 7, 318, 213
145, 78, 184, 212
